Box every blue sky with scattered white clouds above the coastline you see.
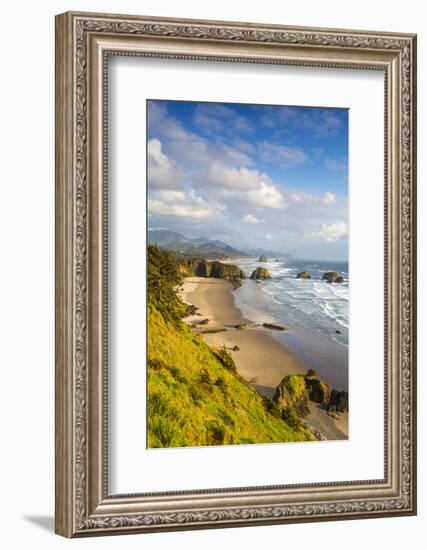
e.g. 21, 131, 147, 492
147, 100, 348, 260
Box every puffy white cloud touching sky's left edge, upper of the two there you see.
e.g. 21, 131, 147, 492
147, 139, 183, 189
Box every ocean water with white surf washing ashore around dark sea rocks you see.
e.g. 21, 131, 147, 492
232, 258, 349, 390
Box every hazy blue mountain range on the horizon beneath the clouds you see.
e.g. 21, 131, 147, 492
148, 229, 249, 260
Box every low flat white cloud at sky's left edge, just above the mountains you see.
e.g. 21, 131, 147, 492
148, 191, 226, 219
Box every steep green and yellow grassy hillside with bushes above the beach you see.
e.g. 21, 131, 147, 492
148, 246, 314, 447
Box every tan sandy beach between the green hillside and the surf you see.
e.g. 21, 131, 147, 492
179, 277, 348, 440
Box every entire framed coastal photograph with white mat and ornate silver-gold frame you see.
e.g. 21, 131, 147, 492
56, 12, 416, 537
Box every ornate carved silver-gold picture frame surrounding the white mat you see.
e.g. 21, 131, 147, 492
56, 12, 416, 537
